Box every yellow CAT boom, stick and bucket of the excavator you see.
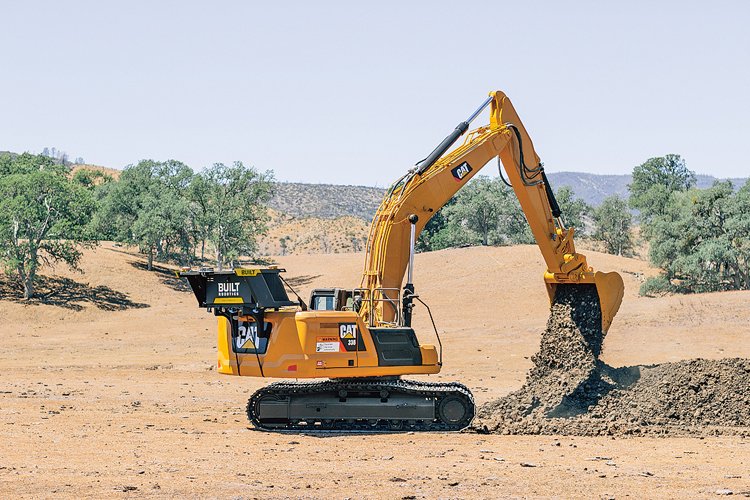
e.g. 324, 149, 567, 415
360, 91, 624, 332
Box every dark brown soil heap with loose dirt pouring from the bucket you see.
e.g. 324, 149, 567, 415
474, 285, 750, 435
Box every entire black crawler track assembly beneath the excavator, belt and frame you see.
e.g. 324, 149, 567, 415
247, 378, 475, 432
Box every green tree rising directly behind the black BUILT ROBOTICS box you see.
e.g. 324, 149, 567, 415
198, 162, 273, 269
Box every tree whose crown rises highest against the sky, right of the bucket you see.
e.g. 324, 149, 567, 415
628, 154, 696, 239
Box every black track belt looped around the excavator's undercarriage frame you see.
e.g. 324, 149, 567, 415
247, 378, 475, 433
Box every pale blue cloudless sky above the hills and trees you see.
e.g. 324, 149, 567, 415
0, 0, 750, 186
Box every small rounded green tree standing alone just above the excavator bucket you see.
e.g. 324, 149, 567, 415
592, 195, 633, 255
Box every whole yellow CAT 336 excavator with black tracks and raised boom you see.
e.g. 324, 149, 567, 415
182, 91, 624, 432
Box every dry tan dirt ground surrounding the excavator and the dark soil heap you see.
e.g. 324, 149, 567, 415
0, 244, 750, 498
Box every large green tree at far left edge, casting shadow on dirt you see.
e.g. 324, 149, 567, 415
0, 153, 94, 299
